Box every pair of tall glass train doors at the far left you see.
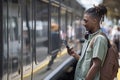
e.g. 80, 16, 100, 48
2, 0, 34, 80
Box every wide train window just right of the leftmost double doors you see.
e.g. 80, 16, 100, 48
35, 0, 49, 62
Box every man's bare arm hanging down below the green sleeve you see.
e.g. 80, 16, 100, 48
85, 58, 101, 80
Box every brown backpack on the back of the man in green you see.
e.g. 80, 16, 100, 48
91, 33, 119, 80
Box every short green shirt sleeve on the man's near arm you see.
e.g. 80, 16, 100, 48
93, 35, 108, 61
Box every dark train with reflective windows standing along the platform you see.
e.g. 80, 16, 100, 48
0, 0, 85, 80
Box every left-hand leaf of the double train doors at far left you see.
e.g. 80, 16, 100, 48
2, 0, 21, 80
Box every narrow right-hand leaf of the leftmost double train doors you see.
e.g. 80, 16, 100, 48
20, 0, 34, 80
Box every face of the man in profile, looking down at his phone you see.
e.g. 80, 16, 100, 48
82, 14, 95, 31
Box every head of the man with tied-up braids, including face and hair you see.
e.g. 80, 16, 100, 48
83, 5, 107, 31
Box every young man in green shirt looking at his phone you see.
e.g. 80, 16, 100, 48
67, 5, 108, 80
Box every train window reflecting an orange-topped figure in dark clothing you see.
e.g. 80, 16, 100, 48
51, 6, 60, 51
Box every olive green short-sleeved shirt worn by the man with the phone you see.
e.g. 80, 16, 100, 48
74, 29, 108, 80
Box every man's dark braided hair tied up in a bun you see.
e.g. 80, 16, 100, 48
85, 4, 107, 21
